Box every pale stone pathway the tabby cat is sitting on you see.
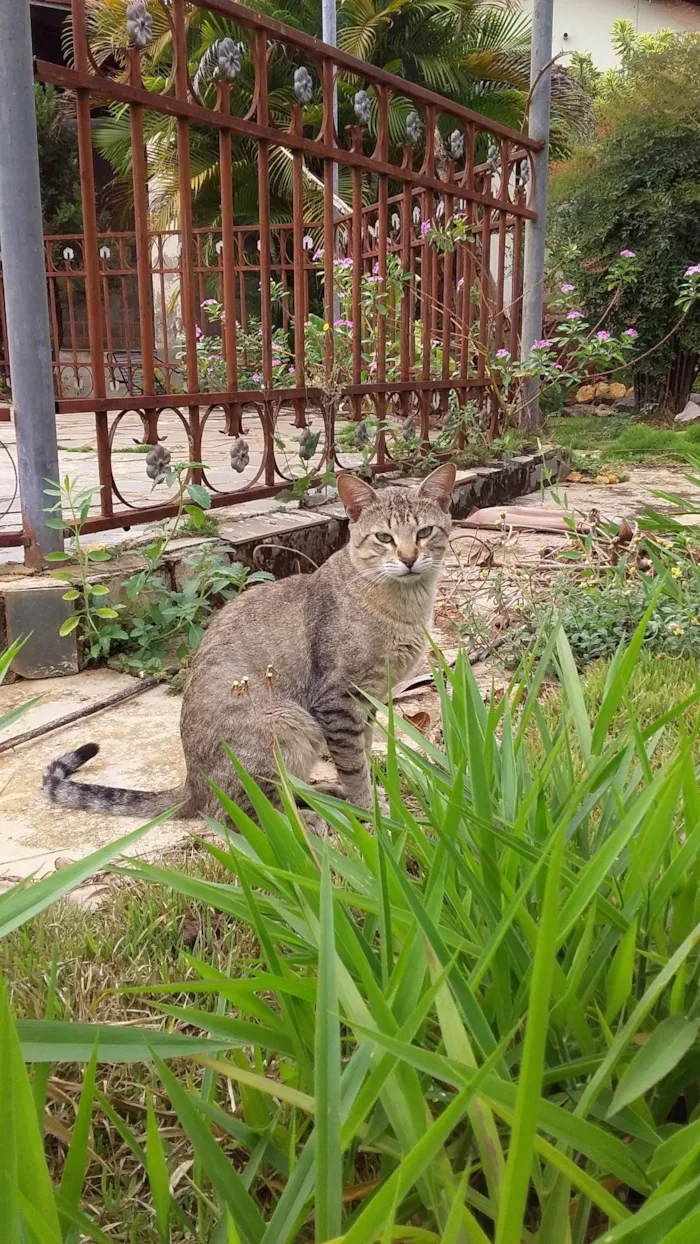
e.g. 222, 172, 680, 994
0, 468, 693, 878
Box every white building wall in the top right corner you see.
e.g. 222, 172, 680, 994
522, 0, 700, 70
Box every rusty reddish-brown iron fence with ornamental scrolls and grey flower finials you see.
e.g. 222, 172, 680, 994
0, 0, 541, 545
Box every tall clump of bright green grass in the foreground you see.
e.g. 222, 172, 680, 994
0, 620, 700, 1244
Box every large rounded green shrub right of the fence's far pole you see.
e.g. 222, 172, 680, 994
551, 35, 700, 408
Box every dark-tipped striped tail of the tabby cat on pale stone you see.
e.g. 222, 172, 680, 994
42, 743, 189, 817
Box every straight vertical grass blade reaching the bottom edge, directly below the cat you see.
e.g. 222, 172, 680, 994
313, 851, 343, 1244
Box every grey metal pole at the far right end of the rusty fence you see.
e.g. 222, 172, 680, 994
521, 0, 555, 428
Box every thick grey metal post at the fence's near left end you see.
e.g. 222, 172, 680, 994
0, 0, 63, 567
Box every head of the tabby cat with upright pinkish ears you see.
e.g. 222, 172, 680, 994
338, 463, 455, 583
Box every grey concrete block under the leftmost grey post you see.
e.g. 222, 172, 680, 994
5, 578, 78, 678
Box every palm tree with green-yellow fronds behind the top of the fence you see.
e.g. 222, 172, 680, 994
88, 0, 589, 226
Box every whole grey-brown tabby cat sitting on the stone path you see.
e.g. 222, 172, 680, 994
44, 464, 455, 817
